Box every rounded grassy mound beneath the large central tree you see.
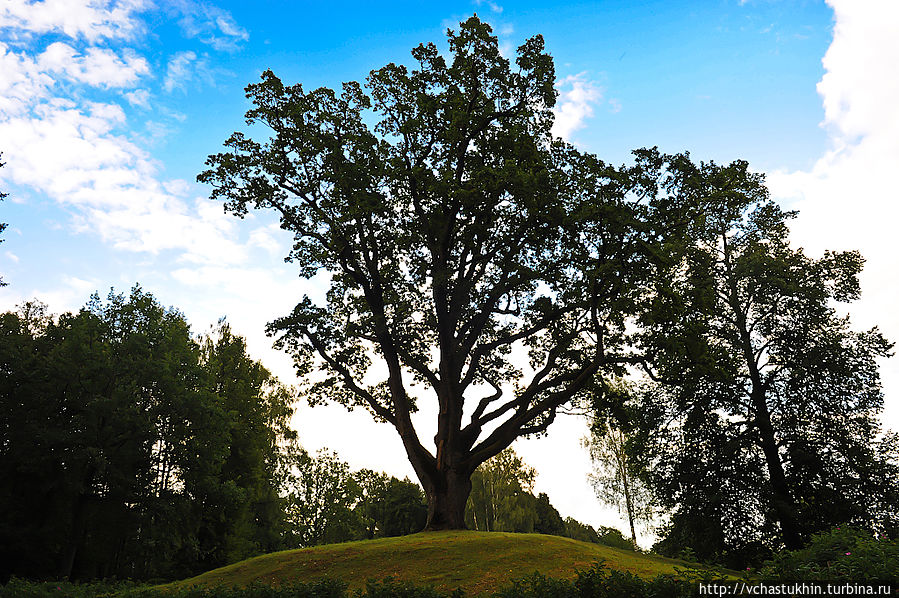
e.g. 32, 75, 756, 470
166, 531, 724, 596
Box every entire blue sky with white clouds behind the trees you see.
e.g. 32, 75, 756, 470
0, 0, 899, 544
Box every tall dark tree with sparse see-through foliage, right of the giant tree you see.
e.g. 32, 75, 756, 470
640, 152, 896, 549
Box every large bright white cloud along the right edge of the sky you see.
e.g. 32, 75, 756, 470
768, 0, 899, 428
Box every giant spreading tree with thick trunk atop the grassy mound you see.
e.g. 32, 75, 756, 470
198, 17, 655, 529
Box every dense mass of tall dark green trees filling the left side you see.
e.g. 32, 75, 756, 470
0, 287, 293, 579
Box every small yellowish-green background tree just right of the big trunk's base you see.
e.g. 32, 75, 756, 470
466, 448, 537, 532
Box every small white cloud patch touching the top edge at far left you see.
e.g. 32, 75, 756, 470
0, 0, 149, 42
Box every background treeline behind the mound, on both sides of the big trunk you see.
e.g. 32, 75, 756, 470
0, 286, 627, 580
